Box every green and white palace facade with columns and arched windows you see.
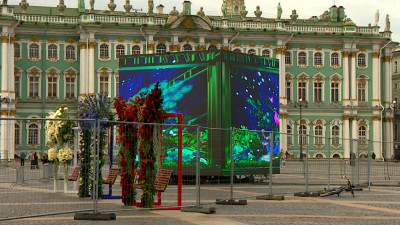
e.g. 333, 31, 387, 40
0, 0, 396, 159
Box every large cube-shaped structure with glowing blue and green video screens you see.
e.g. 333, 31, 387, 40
119, 51, 279, 175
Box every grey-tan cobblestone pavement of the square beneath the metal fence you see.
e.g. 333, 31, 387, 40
0, 161, 400, 225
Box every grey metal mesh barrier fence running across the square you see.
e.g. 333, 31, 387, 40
0, 116, 400, 220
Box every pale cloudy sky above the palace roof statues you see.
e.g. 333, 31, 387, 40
4, 0, 400, 42
